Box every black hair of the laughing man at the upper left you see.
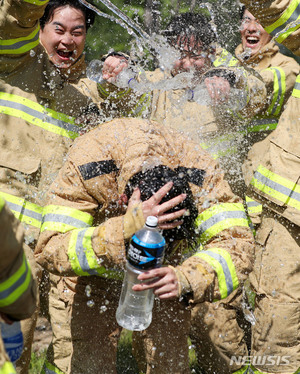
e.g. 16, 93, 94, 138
40, 0, 95, 30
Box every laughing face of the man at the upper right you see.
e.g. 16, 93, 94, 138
240, 10, 271, 55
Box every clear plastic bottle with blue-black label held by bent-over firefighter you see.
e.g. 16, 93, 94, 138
116, 216, 166, 331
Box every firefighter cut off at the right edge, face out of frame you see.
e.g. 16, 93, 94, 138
234, 0, 300, 374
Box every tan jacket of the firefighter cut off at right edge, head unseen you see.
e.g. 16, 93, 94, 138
243, 0, 300, 225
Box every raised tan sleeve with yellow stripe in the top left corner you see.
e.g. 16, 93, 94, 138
0, 0, 48, 72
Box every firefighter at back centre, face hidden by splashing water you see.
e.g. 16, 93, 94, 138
103, 13, 266, 374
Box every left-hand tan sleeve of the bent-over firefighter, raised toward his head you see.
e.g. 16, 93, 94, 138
35, 146, 145, 278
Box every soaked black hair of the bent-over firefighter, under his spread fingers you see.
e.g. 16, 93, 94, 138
125, 165, 198, 245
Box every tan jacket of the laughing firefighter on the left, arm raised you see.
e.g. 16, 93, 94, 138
0, 0, 119, 243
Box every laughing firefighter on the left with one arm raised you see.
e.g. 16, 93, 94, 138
0, 0, 137, 374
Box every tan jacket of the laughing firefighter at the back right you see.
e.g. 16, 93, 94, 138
235, 41, 300, 219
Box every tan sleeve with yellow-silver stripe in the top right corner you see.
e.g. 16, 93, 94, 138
242, 0, 300, 56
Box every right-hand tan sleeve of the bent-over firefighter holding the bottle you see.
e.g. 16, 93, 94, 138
172, 139, 254, 302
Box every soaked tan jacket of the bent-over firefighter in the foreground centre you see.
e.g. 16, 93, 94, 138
35, 118, 253, 301
